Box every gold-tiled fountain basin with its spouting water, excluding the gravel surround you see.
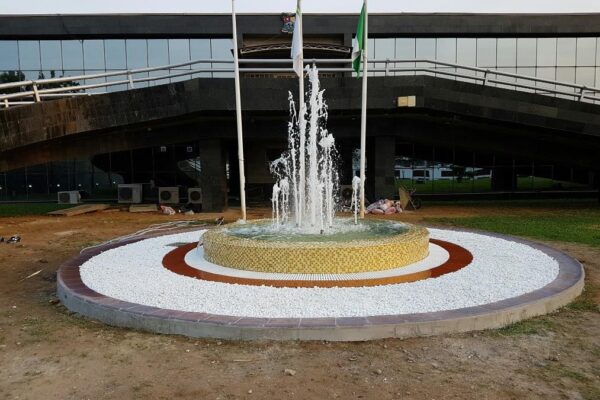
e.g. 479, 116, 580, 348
202, 66, 429, 274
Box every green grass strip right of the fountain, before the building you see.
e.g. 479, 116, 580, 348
426, 208, 600, 247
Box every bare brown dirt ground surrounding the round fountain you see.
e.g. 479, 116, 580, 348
0, 206, 600, 399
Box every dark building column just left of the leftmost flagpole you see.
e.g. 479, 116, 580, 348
198, 140, 227, 212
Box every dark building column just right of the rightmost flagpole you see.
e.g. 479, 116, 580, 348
365, 136, 397, 202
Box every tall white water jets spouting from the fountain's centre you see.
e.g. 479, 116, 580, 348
270, 66, 339, 233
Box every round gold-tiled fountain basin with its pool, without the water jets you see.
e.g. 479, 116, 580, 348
202, 218, 429, 274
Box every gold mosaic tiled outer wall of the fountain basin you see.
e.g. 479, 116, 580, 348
203, 220, 429, 274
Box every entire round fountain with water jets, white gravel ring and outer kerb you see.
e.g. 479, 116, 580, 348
57, 64, 584, 340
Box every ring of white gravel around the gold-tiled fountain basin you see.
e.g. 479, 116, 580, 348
81, 229, 559, 318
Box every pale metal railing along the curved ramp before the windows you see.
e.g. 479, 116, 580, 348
0, 59, 600, 108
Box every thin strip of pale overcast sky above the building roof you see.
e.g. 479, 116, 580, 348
0, 0, 600, 15
